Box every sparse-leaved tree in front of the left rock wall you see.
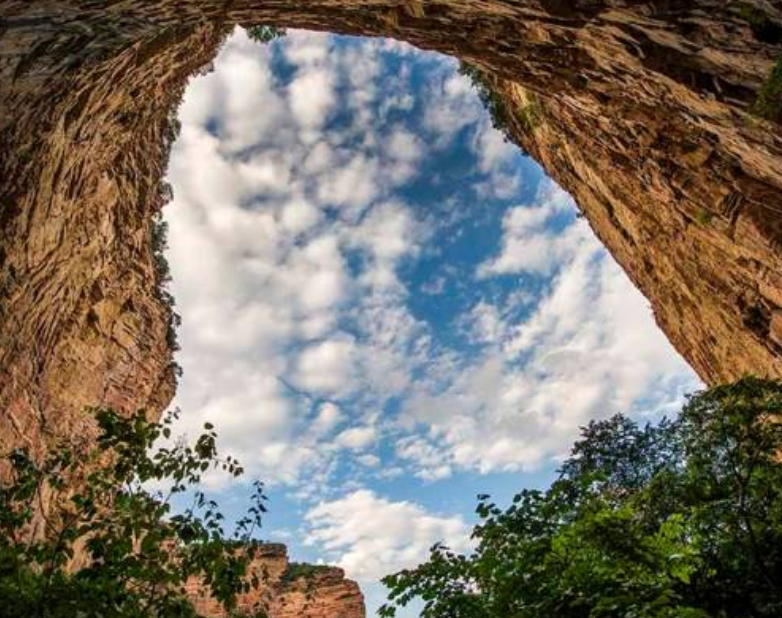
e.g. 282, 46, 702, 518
0, 409, 266, 618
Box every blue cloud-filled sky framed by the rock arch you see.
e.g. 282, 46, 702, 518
164, 28, 700, 618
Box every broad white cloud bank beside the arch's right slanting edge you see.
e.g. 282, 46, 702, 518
397, 182, 698, 480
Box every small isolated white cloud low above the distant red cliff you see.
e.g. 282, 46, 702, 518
305, 489, 470, 581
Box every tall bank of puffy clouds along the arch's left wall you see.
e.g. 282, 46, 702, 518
165, 30, 438, 485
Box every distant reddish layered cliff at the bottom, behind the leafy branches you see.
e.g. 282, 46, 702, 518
188, 544, 365, 618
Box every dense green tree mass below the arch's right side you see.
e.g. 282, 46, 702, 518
381, 378, 782, 618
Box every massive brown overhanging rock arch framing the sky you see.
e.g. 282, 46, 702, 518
0, 0, 782, 516
